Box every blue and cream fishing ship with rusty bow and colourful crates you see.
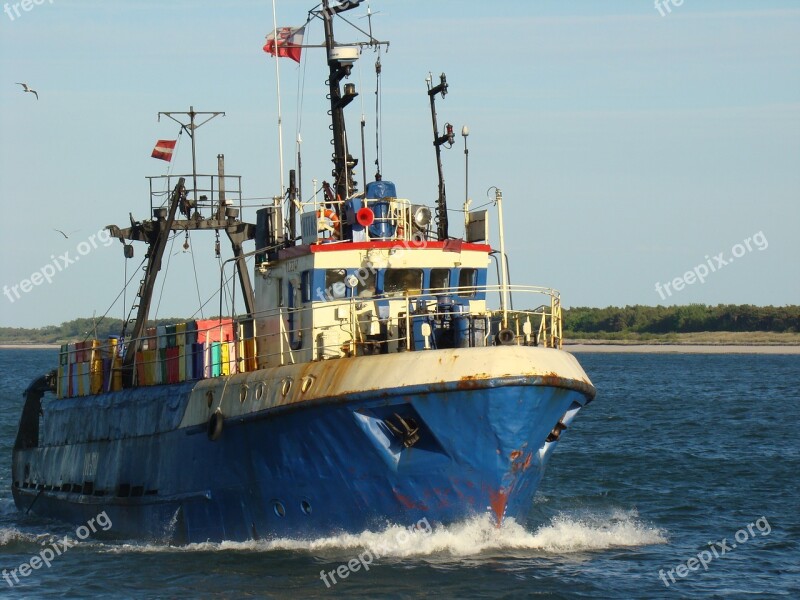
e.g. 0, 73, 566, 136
12, 0, 595, 544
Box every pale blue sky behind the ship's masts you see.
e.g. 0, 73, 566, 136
0, 0, 800, 327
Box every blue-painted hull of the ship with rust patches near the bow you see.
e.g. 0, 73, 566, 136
14, 377, 587, 543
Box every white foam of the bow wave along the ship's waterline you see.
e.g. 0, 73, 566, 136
107, 511, 667, 558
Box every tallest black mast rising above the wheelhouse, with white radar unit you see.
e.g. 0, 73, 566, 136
321, 0, 360, 200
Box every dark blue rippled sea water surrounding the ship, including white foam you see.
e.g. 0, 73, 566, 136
0, 349, 800, 598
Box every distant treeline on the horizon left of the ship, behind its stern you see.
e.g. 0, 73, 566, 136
0, 318, 186, 344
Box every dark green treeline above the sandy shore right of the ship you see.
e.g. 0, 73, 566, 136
563, 304, 800, 336
